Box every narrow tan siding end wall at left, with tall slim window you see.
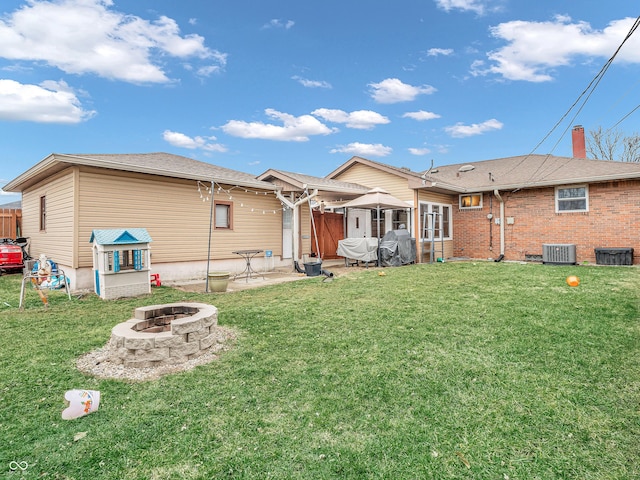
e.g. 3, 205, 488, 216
22, 169, 74, 266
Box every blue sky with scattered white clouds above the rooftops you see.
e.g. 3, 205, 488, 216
0, 0, 640, 204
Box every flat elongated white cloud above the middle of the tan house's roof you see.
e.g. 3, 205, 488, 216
221, 108, 335, 142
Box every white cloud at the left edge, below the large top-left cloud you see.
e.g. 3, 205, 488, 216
0, 80, 96, 123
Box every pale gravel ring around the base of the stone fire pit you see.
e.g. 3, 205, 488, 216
76, 326, 238, 382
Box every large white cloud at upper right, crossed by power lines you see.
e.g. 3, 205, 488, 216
471, 16, 640, 82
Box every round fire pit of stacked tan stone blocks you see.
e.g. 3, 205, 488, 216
109, 303, 226, 368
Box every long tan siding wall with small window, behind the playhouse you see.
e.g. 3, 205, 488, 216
78, 168, 282, 266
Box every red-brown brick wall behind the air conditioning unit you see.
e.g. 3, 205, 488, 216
453, 180, 640, 264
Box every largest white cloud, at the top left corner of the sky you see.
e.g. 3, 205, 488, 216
0, 0, 226, 83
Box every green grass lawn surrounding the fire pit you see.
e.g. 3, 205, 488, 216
0, 262, 640, 480
